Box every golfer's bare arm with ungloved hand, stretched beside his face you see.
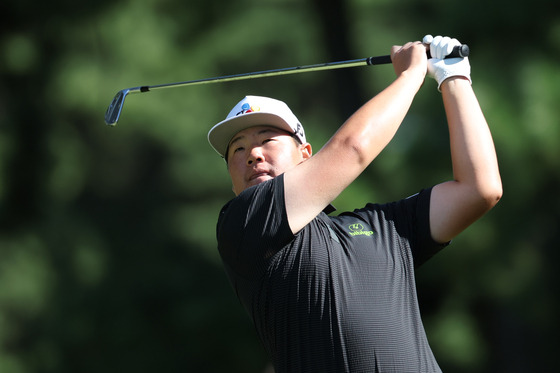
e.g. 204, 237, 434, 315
284, 42, 427, 233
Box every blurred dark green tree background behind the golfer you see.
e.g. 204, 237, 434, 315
0, 0, 560, 373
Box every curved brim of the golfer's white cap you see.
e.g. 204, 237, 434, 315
208, 111, 294, 158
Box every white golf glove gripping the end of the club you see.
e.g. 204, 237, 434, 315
422, 35, 472, 92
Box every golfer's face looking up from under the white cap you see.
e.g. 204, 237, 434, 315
227, 126, 311, 195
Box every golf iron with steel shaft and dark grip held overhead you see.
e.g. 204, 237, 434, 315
105, 44, 470, 126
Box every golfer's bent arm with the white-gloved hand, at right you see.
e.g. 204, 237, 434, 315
428, 37, 502, 243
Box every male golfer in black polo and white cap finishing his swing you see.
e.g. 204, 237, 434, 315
208, 35, 502, 373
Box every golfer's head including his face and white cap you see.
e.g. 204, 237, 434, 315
208, 96, 311, 195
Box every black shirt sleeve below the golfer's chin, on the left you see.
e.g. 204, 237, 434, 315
217, 175, 293, 280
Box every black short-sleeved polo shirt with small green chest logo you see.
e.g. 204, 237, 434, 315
217, 176, 444, 373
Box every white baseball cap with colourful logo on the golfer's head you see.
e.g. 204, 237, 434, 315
208, 96, 306, 158
